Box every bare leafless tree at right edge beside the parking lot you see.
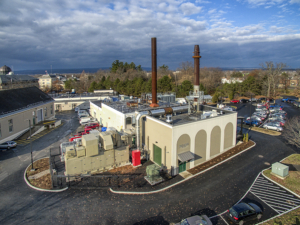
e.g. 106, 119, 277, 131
282, 116, 300, 148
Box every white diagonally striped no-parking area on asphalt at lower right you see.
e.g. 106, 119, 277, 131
250, 175, 300, 214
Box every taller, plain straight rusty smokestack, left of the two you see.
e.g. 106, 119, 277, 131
150, 38, 159, 107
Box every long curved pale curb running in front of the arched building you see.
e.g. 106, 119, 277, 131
109, 140, 256, 195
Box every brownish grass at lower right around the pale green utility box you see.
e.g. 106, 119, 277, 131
263, 154, 300, 225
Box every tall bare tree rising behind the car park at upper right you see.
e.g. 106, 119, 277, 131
260, 61, 286, 97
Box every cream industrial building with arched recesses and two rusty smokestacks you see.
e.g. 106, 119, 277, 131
90, 38, 237, 175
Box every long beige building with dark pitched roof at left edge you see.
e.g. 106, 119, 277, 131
0, 87, 55, 143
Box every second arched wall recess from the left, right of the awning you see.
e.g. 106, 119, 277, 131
195, 130, 207, 166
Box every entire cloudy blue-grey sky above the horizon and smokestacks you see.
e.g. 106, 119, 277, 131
0, 0, 300, 70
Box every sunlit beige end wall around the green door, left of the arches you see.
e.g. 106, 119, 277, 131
145, 116, 172, 170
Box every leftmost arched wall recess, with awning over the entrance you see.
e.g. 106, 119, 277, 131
177, 134, 194, 173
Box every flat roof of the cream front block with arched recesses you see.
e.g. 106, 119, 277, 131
150, 105, 237, 126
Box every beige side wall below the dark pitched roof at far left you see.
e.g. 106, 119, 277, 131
0, 102, 55, 143
